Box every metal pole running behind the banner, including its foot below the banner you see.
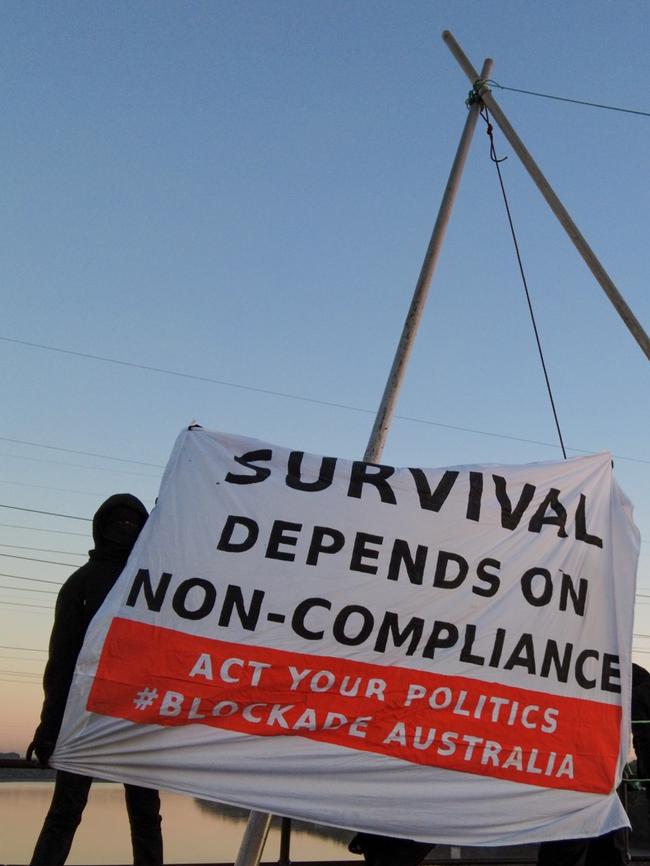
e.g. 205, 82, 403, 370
235, 58, 493, 866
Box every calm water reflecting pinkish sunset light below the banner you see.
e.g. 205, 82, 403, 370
0, 782, 350, 866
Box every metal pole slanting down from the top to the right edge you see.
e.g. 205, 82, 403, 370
442, 30, 650, 359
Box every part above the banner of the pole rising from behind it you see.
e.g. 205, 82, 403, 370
363, 57, 493, 463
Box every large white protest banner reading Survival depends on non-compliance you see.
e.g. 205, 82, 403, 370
52, 427, 639, 845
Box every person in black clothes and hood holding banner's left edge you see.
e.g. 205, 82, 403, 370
27, 493, 163, 866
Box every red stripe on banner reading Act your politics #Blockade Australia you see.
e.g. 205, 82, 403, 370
87, 618, 621, 794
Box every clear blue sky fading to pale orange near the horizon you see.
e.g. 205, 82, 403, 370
0, 0, 650, 748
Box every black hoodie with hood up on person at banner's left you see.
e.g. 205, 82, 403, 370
34, 493, 148, 744
